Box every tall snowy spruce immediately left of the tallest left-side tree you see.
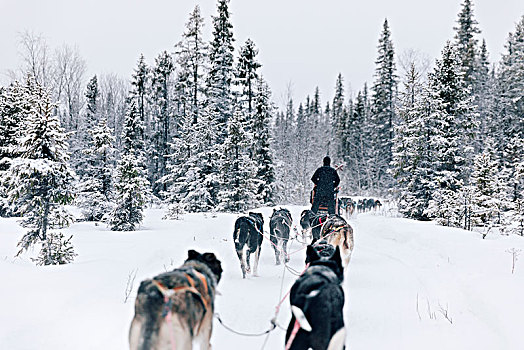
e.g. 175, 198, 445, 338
164, 6, 211, 213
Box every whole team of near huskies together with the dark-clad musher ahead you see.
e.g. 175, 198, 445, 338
129, 157, 362, 350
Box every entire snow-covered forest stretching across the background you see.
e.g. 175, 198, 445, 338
0, 0, 524, 264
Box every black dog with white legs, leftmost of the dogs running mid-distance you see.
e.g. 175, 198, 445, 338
233, 212, 264, 278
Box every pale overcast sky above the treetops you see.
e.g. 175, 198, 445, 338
0, 0, 524, 105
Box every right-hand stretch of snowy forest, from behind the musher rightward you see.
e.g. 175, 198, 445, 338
274, 0, 524, 235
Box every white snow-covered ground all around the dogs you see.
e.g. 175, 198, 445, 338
0, 207, 524, 350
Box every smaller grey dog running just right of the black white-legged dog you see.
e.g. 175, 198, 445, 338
269, 208, 293, 265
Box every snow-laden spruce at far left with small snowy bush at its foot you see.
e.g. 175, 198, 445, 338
2, 77, 76, 265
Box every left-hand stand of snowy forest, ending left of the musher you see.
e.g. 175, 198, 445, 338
0, 0, 275, 264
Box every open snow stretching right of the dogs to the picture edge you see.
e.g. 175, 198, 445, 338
346, 214, 524, 349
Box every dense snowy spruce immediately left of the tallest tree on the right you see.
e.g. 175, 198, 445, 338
428, 42, 475, 226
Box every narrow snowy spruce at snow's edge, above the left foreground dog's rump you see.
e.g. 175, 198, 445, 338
109, 98, 149, 231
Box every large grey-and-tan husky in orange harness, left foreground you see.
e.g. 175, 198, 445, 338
129, 250, 222, 350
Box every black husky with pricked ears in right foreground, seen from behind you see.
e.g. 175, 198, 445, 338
286, 246, 346, 350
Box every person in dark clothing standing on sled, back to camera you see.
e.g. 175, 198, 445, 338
311, 156, 340, 214
